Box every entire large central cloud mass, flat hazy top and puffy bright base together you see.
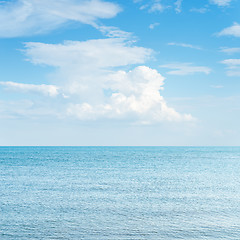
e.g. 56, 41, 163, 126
18, 38, 193, 124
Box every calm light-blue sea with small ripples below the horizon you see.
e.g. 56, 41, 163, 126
0, 147, 240, 240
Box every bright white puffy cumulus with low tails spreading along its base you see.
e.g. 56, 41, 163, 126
68, 66, 193, 124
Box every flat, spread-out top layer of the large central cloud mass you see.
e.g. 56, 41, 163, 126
25, 38, 152, 68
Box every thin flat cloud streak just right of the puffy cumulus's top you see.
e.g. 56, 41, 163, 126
160, 63, 211, 75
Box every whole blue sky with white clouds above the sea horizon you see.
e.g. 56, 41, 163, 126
0, 0, 240, 146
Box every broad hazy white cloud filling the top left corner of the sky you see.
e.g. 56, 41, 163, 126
0, 0, 121, 37
